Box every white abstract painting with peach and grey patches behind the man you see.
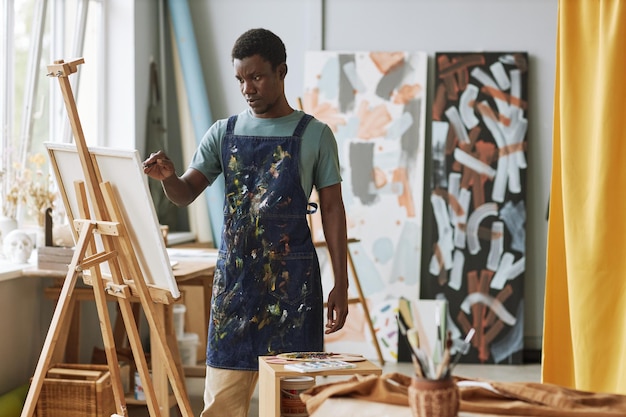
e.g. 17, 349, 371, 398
302, 51, 427, 360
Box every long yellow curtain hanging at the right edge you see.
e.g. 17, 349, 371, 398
542, 0, 626, 394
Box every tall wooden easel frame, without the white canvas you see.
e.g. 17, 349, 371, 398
21, 58, 193, 417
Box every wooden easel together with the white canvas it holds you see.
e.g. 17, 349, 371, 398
22, 58, 193, 417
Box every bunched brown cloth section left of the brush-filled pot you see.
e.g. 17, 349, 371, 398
300, 373, 411, 414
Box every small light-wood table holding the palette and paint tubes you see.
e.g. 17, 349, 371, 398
259, 356, 382, 417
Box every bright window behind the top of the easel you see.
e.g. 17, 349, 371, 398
0, 0, 104, 225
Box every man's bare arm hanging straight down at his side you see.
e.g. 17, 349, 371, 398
318, 183, 348, 334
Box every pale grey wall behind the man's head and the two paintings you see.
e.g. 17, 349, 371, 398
182, 0, 557, 349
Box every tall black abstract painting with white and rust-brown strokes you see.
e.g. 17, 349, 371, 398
421, 52, 528, 363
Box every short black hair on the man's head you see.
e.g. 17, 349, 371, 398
231, 28, 287, 69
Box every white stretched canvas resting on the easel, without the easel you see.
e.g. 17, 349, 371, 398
45, 143, 180, 299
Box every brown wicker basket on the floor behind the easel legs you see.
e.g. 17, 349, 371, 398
35, 364, 116, 417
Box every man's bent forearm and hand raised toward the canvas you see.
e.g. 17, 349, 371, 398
143, 151, 209, 207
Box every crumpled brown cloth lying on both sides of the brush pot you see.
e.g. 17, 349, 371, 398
300, 373, 626, 417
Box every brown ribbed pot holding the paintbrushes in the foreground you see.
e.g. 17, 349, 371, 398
409, 377, 459, 417
